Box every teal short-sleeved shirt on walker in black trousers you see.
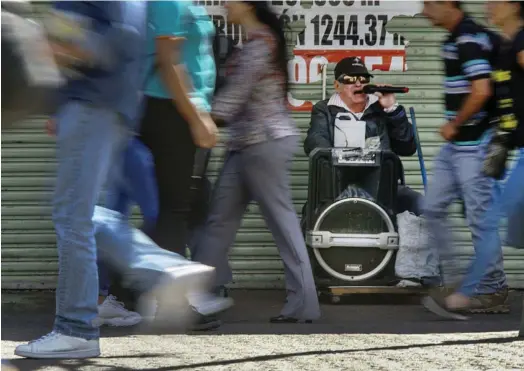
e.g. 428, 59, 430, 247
144, 1, 216, 112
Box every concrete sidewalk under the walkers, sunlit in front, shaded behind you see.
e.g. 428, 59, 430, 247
2, 291, 524, 371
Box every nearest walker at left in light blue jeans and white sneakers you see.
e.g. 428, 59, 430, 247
15, 1, 214, 358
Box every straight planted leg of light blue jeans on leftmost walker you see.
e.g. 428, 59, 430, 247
53, 101, 128, 339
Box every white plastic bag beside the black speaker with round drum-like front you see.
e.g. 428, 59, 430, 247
395, 211, 439, 280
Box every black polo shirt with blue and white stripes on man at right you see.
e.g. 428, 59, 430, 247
442, 17, 499, 145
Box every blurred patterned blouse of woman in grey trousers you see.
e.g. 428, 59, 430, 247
212, 29, 299, 150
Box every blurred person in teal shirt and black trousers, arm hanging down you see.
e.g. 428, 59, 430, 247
140, 1, 217, 255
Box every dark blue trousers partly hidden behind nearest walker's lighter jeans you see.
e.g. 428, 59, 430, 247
98, 138, 158, 296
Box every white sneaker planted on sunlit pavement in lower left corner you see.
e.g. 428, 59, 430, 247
15, 331, 100, 359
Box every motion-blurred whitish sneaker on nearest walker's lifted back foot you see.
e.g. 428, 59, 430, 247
139, 263, 215, 329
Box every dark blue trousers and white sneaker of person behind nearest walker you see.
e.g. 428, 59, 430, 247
95, 137, 158, 326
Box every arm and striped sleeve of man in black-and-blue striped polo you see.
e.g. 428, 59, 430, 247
453, 34, 493, 127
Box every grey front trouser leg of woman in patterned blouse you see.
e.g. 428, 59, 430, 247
242, 137, 320, 321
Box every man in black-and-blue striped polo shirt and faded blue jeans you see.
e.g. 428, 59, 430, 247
423, 1, 509, 313
